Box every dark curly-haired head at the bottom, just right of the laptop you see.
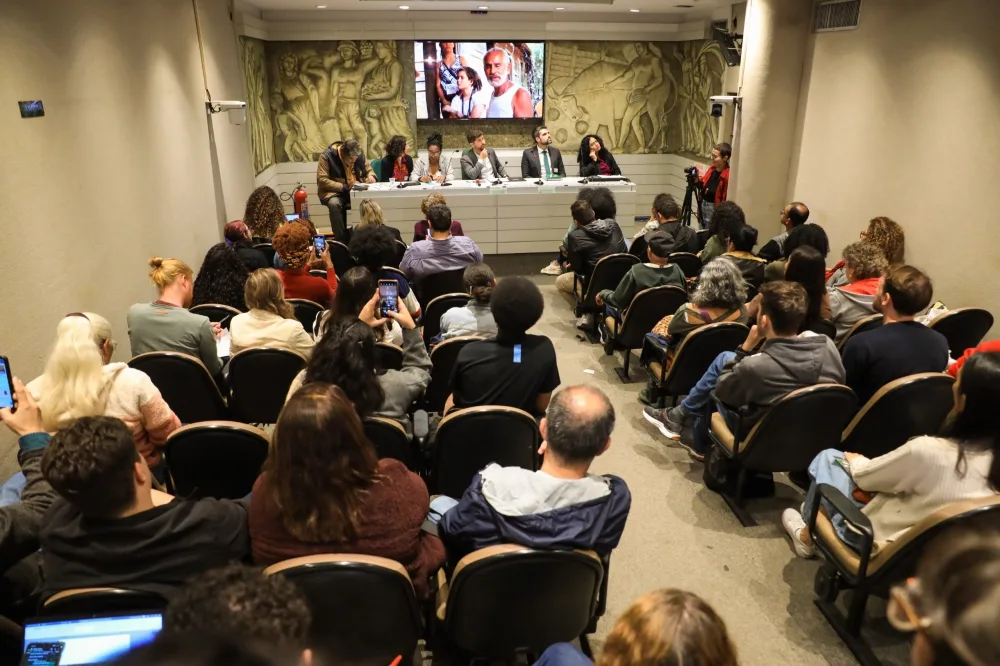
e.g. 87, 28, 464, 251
163, 563, 312, 651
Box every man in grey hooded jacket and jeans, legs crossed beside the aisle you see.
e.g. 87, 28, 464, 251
643, 281, 844, 460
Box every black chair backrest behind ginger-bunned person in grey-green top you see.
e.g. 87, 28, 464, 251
128, 352, 229, 423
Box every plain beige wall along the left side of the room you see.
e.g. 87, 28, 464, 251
0, 0, 253, 466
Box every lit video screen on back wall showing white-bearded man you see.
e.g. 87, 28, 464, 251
413, 42, 545, 120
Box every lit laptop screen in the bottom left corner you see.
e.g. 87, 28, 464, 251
21, 613, 163, 666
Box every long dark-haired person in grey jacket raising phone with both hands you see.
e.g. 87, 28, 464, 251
285, 293, 431, 434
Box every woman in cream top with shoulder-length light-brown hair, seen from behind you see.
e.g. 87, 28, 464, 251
229, 268, 316, 360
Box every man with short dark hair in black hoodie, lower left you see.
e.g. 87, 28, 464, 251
38, 416, 250, 598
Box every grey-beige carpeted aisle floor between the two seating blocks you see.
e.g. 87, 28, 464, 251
496, 255, 909, 666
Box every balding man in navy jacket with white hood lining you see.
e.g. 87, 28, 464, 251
439, 385, 632, 562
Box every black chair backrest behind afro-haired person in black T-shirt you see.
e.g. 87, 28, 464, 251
433, 406, 541, 497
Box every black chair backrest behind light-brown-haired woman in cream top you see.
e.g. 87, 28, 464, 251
229, 347, 306, 423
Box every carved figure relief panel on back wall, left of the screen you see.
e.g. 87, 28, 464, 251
264, 40, 415, 162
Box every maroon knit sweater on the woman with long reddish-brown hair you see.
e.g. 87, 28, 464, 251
250, 458, 445, 598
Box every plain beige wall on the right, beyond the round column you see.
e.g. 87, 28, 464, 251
788, 0, 1000, 336
